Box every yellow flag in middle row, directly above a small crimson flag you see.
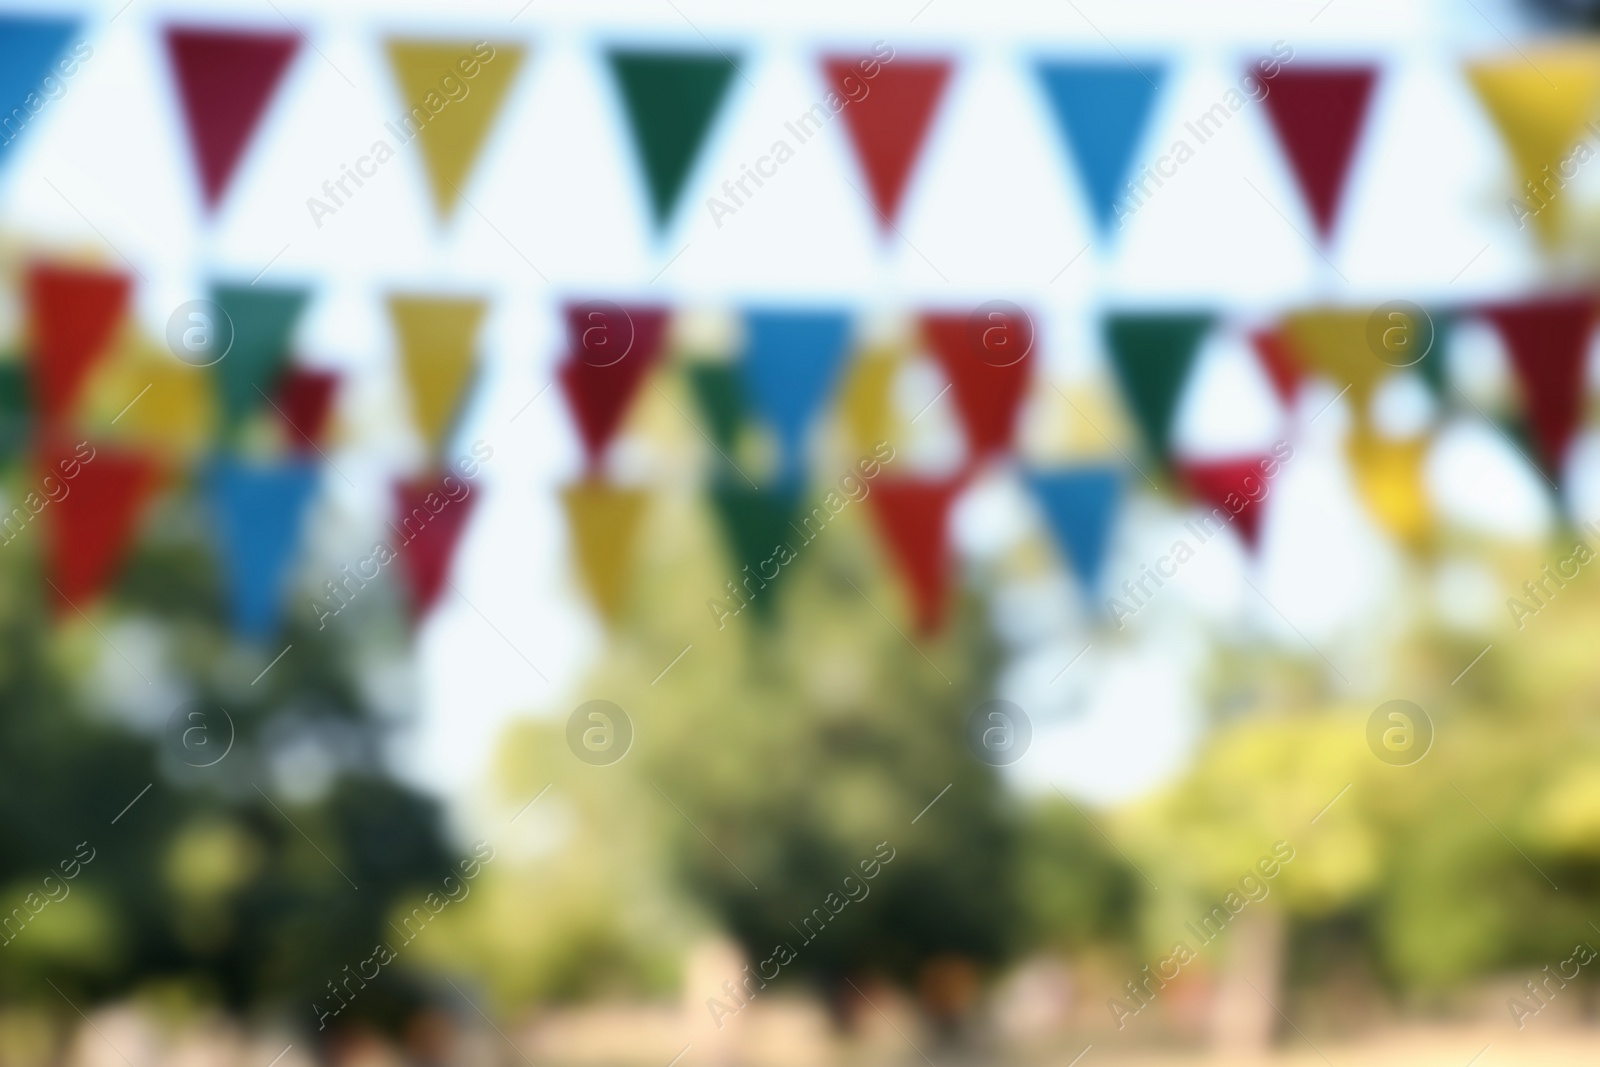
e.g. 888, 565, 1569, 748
389, 296, 485, 456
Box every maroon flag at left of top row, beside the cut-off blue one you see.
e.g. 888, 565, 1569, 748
166, 26, 299, 211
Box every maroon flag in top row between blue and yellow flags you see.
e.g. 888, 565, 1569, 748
1266, 66, 1378, 240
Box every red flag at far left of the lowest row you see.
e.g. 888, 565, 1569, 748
39, 440, 158, 611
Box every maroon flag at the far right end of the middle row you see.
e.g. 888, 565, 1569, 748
1483, 296, 1595, 477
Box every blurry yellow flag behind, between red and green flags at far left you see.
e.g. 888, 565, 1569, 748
75, 323, 216, 459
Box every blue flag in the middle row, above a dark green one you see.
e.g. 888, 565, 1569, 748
741, 310, 850, 475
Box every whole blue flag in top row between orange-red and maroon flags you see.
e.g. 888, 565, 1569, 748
1038, 61, 1165, 235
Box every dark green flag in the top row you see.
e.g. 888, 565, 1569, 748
610, 48, 736, 226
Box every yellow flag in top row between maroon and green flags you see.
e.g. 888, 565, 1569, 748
386, 38, 525, 219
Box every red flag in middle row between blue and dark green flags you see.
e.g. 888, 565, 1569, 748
922, 312, 1032, 459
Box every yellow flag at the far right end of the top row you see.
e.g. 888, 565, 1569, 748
1467, 46, 1600, 246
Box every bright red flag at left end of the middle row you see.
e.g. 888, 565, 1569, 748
26, 264, 130, 424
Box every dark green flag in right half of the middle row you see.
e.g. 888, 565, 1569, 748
1106, 312, 1211, 461
